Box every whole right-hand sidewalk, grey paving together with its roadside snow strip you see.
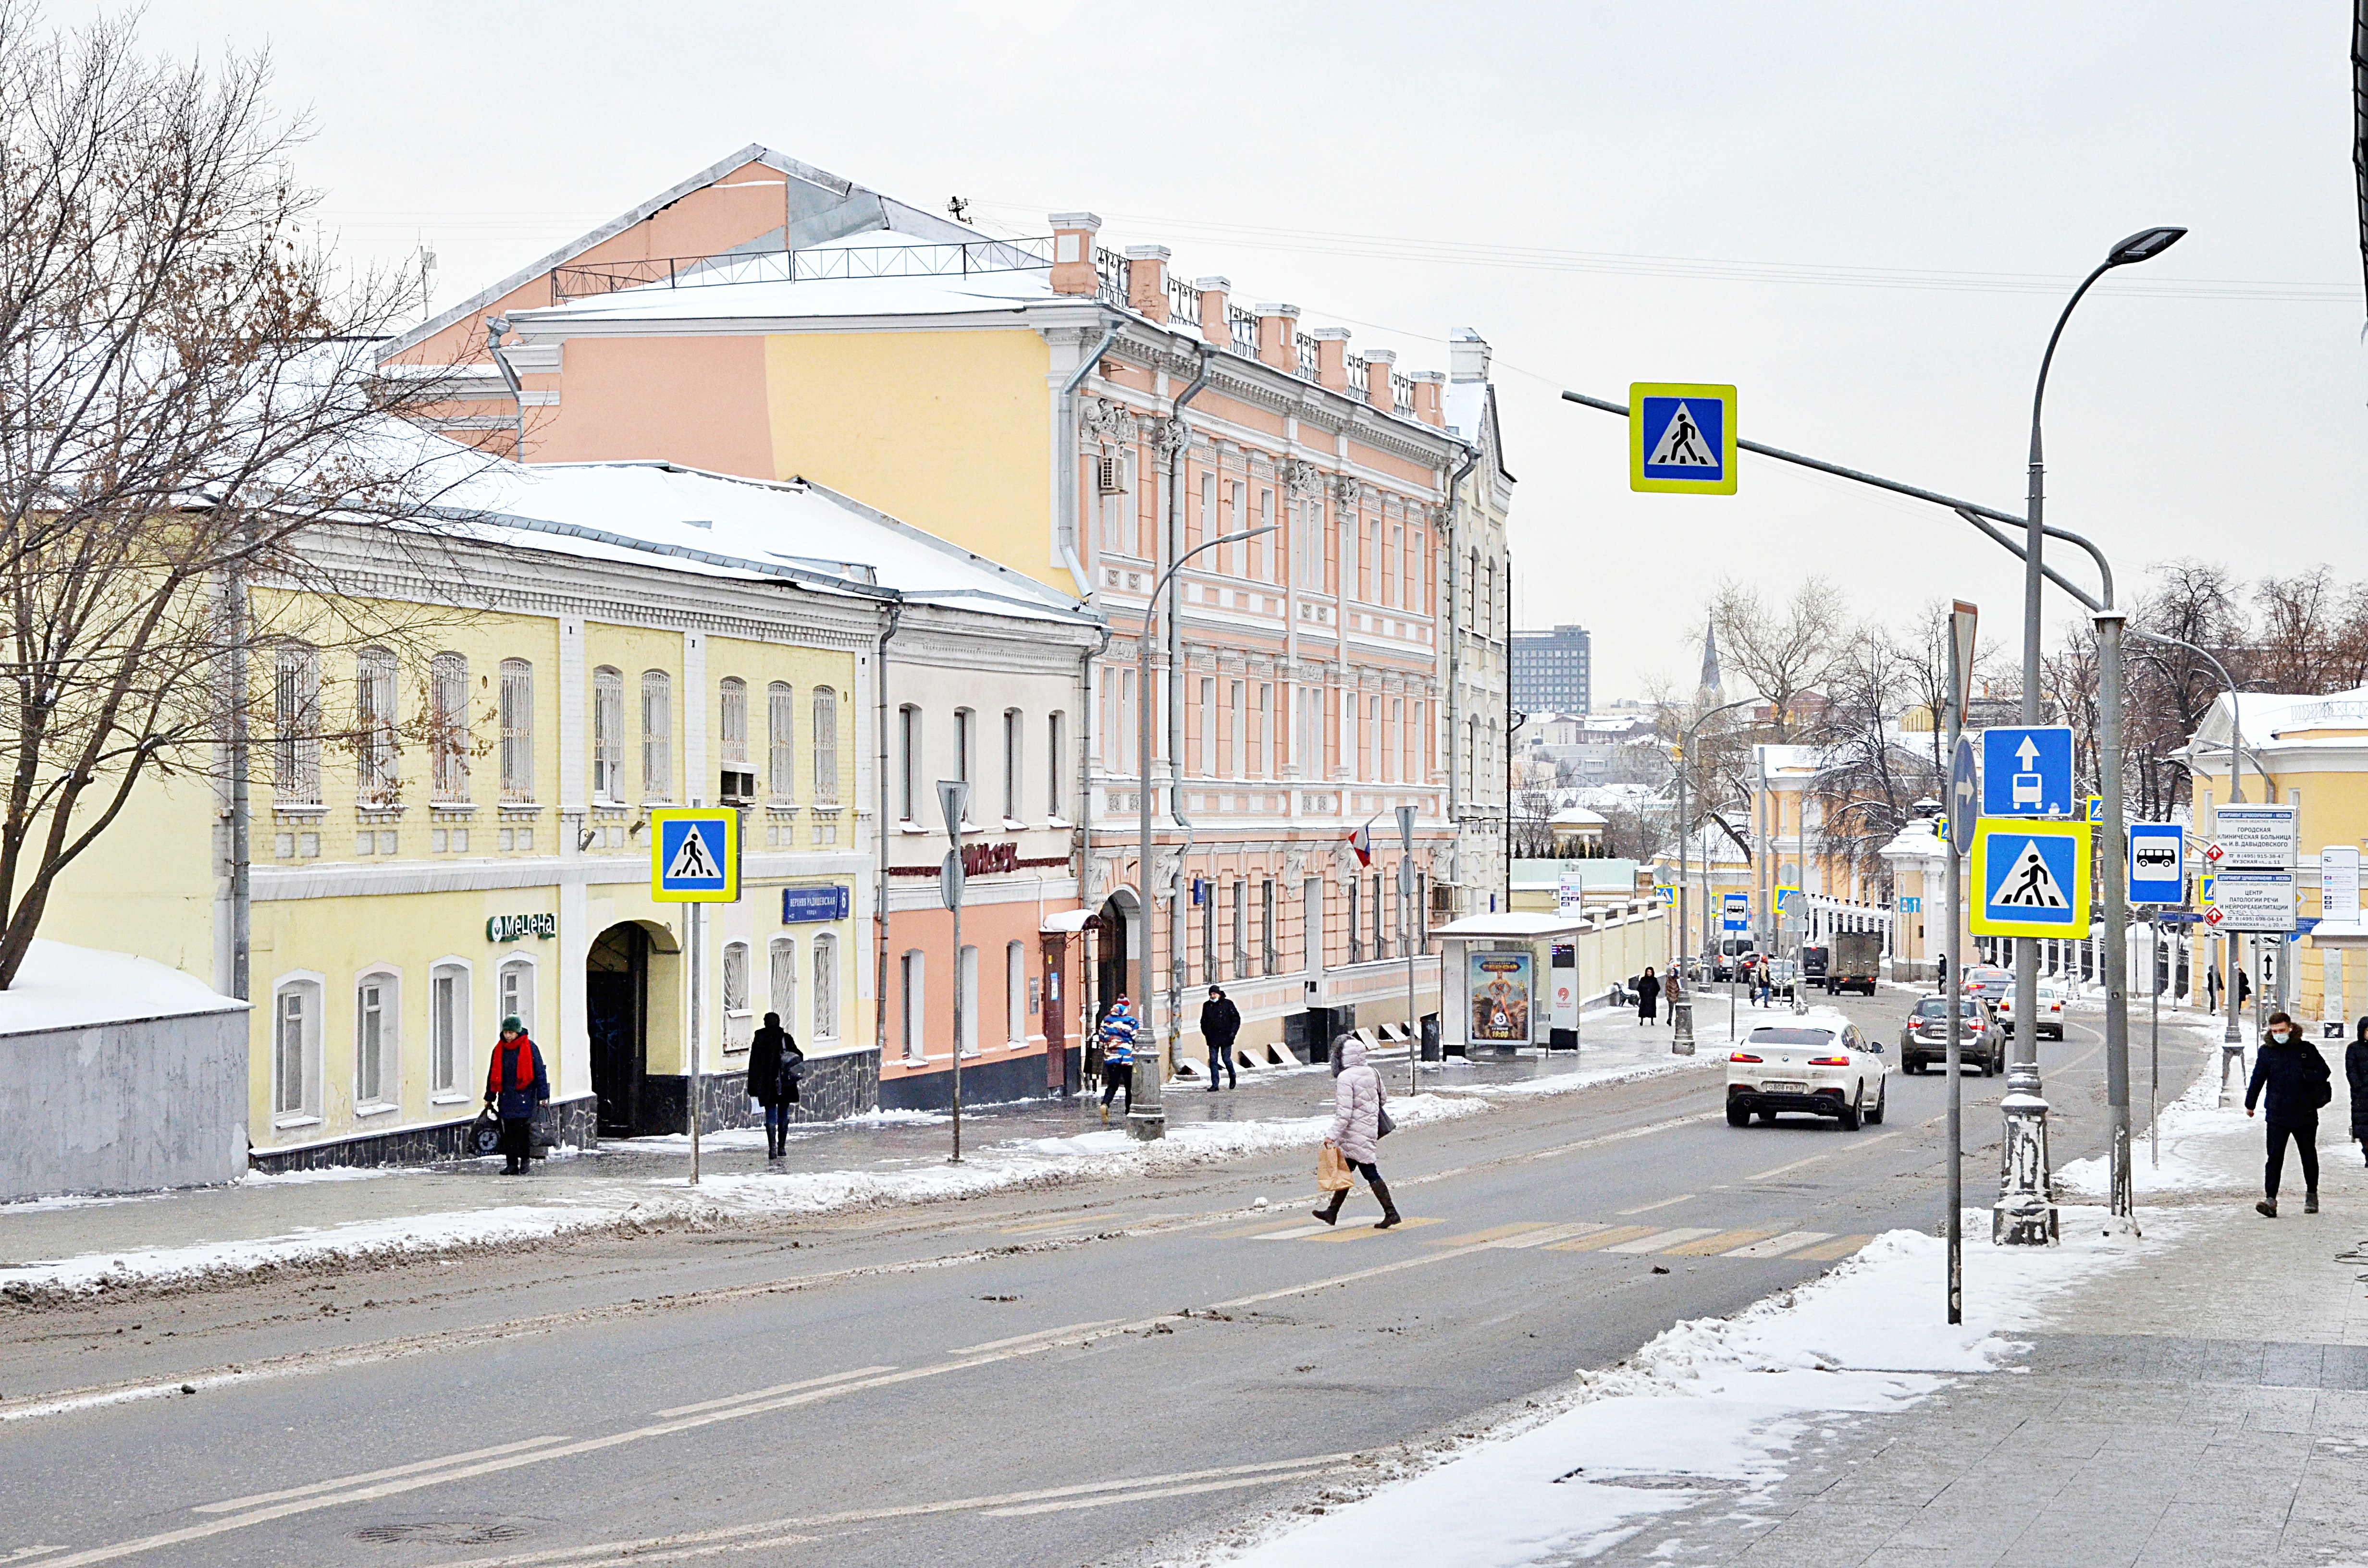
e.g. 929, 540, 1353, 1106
1203, 1030, 2368, 1568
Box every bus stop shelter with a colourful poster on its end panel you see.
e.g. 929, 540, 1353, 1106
1431, 912, 1591, 1056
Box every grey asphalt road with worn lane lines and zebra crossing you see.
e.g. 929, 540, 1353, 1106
0, 992, 2200, 1568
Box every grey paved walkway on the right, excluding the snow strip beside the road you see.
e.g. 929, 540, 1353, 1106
1598, 1018, 2368, 1568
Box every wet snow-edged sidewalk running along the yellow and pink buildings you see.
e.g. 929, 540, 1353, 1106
0, 1014, 1717, 1291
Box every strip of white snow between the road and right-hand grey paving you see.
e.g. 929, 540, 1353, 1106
1227, 1215, 2143, 1568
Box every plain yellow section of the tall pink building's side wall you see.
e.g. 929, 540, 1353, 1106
765, 327, 1056, 592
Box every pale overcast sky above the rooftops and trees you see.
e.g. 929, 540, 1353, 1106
69, 0, 2368, 706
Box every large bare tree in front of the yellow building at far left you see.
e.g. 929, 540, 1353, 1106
0, 12, 461, 988
